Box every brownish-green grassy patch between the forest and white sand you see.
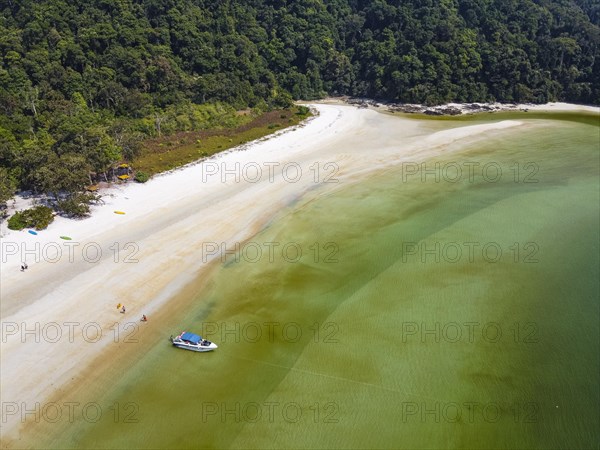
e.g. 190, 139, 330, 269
133, 108, 310, 175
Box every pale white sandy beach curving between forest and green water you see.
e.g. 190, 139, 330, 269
0, 100, 598, 446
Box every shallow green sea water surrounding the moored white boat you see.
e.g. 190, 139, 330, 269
45, 111, 600, 449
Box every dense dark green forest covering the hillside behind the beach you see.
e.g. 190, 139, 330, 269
0, 0, 600, 216
